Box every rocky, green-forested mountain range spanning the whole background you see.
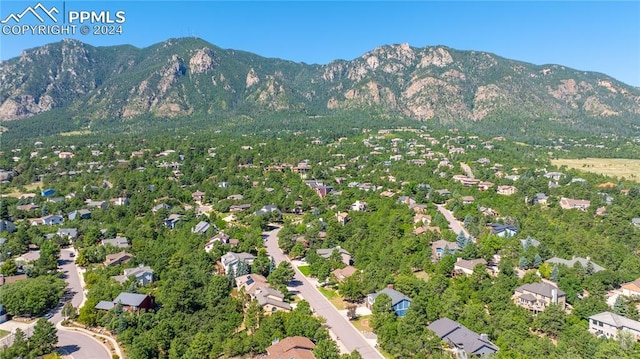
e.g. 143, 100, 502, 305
0, 38, 640, 133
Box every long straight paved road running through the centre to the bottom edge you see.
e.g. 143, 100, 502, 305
265, 229, 384, 359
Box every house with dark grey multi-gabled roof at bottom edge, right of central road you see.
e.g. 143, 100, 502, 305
427, 318, 500, 359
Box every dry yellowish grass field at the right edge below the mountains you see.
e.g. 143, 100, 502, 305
551, 158, 640, 182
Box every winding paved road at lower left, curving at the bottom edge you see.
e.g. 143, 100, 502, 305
54, 249, 111, 359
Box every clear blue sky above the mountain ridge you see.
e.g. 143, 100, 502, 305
0, 0, 640, 86
